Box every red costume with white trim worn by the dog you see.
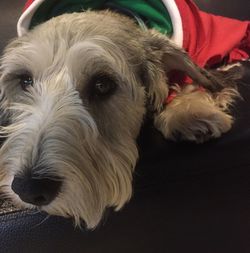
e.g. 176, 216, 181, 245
18, 0, 250, 102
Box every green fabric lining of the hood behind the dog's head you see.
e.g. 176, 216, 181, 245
31, 0, 173, 36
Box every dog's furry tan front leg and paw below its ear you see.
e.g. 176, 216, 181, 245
154, 85, 237, 143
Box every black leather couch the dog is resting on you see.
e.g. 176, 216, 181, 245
0, 0, 250, 253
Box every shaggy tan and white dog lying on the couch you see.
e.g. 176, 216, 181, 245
0, 7, 247, 228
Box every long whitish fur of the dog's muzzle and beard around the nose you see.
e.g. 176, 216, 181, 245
0, 86, 138, 228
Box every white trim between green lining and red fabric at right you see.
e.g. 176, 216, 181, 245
162, 0, 183, 47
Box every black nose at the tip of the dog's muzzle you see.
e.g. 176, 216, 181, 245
11, 175, 62, 206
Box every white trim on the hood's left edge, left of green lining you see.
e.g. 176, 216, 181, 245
17, 0, 45, 37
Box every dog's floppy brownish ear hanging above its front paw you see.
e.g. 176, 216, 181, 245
144, 30, 222, 111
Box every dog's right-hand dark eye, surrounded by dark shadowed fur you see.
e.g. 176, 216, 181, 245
91, 76, 116, 97
